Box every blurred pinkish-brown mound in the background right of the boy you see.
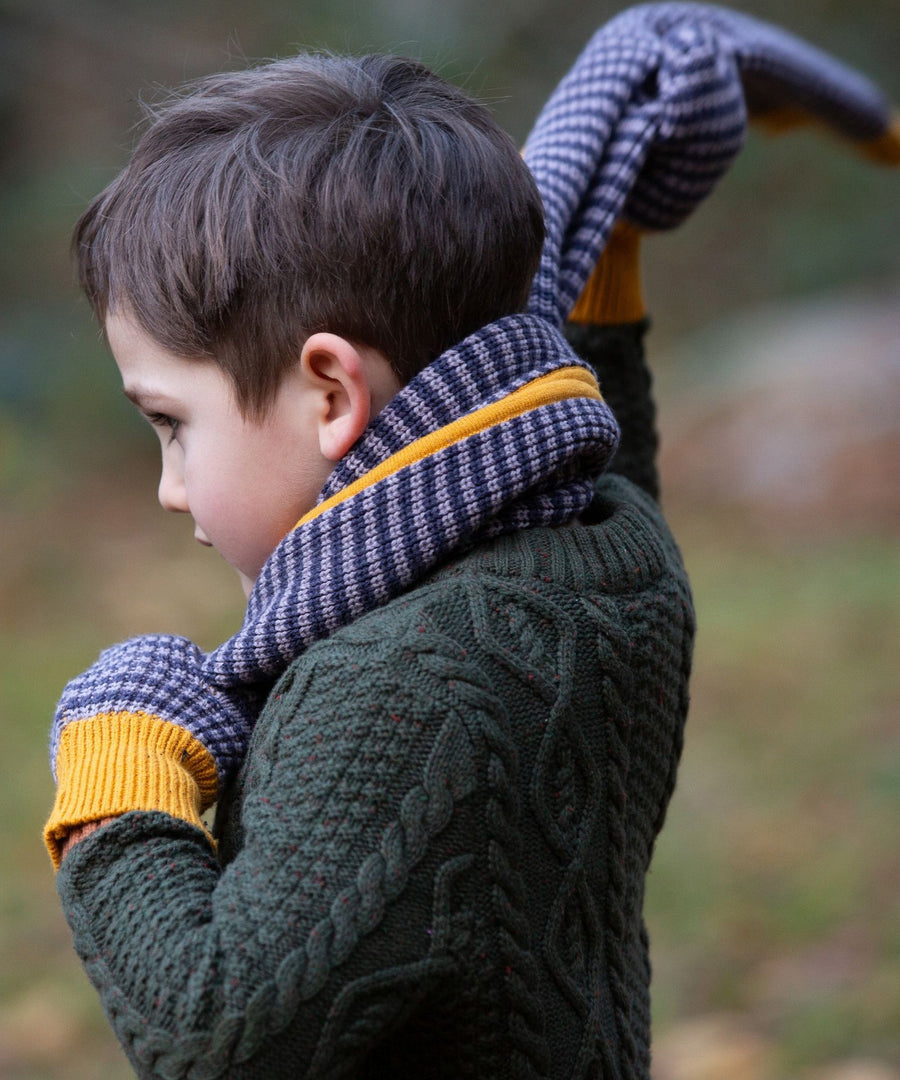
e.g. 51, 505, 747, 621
650, 295, 900, 531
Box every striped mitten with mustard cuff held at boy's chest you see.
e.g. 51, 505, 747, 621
44, 635, 255, 867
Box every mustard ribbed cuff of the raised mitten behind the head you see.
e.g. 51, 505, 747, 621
568, 221, 647, 326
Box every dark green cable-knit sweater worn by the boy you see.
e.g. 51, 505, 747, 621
58, 325, 694, 1080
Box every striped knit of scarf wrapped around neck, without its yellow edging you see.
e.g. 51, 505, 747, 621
204, 315, 618, 686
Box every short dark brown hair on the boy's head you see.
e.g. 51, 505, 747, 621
72, 54, 543, 416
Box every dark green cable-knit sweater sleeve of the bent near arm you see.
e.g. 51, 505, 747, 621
58, 604, 518, 1080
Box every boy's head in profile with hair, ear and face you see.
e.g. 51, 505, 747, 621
73, 50, 543, 590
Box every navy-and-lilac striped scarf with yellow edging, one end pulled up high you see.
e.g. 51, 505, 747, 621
203, 3, 890, 687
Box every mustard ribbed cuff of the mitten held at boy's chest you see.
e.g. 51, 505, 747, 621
44, 713, 218, 869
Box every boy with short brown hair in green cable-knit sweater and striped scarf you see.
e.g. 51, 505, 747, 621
45, 8, 894, 1078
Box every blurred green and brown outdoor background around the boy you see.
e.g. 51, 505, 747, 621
0, 0, 900, 1080
